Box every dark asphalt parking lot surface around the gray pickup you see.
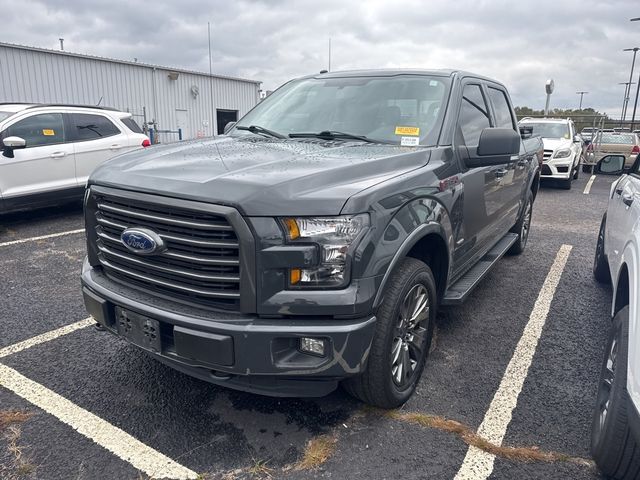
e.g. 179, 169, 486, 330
0, 174, 614, 480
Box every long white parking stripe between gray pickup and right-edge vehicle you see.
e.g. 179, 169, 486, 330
455, 245, 573, 480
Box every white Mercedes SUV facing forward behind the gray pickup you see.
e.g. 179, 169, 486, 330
518, 117, 584, 190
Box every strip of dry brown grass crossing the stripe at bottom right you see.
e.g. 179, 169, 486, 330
385, 410, 594, 467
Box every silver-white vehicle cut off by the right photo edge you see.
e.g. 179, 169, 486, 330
591, 155, 640, 480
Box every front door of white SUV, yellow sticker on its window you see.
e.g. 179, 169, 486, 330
0, 113, 76, 201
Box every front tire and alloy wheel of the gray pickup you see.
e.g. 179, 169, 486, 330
342, 258, 437, 408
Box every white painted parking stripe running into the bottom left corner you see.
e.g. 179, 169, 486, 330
0, 364, 198, 479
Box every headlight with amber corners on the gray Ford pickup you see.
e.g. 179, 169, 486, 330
281, 214, 369, 287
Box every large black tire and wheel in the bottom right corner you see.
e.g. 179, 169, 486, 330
591, 306, 640, 480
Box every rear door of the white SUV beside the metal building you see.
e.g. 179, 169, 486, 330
66, 112, 129, 186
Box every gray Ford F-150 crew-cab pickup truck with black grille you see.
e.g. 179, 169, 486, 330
82, 70, 542, 408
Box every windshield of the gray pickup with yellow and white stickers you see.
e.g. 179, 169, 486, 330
232, 74, 449, 145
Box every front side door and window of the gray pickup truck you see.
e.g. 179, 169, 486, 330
454, 80, 509, 275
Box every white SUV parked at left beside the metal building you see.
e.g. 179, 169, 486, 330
0, 103, 150, 213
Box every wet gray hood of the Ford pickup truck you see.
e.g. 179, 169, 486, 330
89, 136, 430, 216
